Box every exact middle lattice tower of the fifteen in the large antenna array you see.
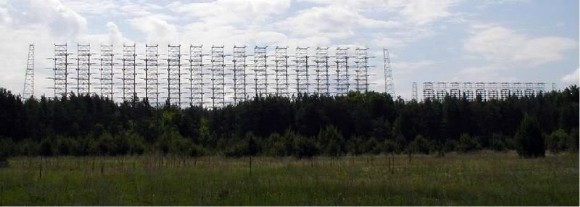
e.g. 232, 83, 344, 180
210, 46, 225, 108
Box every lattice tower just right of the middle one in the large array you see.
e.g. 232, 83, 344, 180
232, 45, 248, 104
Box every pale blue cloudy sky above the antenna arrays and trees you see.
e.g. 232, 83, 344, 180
0, 0, 579, 99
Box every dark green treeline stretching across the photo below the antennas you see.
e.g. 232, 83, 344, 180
0, 85, 579, 158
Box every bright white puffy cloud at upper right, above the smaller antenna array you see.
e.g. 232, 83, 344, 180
464, 25, 577, 65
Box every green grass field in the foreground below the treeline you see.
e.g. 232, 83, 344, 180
0, 152, 579, 206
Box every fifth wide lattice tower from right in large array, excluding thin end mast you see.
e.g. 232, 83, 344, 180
274, 47, 289, 96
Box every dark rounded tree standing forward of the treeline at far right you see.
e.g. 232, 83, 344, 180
515, 116, 546, 158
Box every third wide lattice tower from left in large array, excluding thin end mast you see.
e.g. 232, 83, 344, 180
99, 45, 115, 100
